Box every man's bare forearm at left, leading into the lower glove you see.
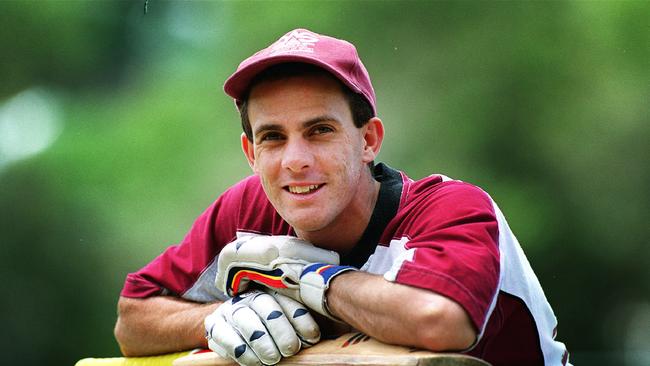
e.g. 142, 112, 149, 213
115, 296, 219, 356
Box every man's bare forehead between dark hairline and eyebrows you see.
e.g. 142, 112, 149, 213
248, 74, 352, 127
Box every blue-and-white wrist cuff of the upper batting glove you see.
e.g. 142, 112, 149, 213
300, 263, 358, 321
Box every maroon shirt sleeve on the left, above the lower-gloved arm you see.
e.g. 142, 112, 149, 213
121, 181, 245, 298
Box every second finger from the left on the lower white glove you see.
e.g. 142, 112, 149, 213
227, 298, 282, 365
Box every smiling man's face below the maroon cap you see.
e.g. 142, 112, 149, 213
242, 75, 383, 233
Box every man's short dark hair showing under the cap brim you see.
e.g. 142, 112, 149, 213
238, 62, 375, 141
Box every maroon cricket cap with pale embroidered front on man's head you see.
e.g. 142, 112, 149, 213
223, 29, 377, 114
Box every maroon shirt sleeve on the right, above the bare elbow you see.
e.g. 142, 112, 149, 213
391, 181, 499, 329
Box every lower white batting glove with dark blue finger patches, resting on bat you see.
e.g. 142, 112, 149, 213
204, 290, 320, 366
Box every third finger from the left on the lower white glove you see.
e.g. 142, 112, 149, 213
249, 293, 300, 357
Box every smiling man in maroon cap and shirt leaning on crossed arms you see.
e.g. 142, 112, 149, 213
115, 29, 568, 365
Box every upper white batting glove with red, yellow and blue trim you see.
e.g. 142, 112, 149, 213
215, 236, 356, 320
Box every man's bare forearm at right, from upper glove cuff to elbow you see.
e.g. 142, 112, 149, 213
327, 272, 475, 351
